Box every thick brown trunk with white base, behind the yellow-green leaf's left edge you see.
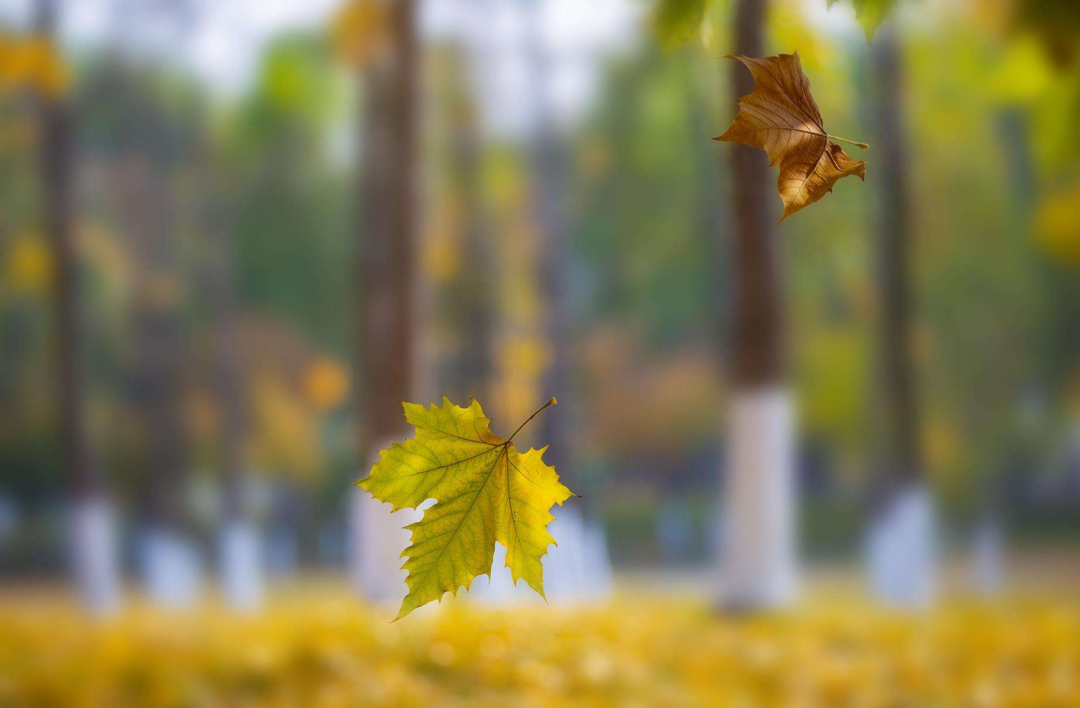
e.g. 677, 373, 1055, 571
352, 0, 419, 598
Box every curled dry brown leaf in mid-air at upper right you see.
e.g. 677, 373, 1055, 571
713, 52, 869, 221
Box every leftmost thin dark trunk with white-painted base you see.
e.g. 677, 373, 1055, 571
37, 0, 120, 614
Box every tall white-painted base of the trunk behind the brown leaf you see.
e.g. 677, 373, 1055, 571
718, 386, 796, 609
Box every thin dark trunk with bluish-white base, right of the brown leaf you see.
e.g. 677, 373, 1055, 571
869, 27, 933, 607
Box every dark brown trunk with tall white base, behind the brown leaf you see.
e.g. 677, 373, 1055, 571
720, 0, 795, 609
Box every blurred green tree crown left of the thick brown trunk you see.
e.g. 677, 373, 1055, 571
228, 36, 355, 354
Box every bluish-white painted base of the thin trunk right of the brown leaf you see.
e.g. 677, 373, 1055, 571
866, 484, 935, 610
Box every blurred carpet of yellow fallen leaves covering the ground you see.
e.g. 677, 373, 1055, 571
0, 586, 1080, 708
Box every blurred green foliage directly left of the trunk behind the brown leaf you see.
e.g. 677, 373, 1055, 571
576, 47, 723, 348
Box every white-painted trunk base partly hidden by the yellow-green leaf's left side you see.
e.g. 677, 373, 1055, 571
349, 488, 421, 602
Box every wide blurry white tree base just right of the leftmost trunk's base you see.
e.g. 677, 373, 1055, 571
143, 528, 202, 609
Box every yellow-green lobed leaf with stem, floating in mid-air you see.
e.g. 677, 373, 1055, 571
356, 396, 572, 620
